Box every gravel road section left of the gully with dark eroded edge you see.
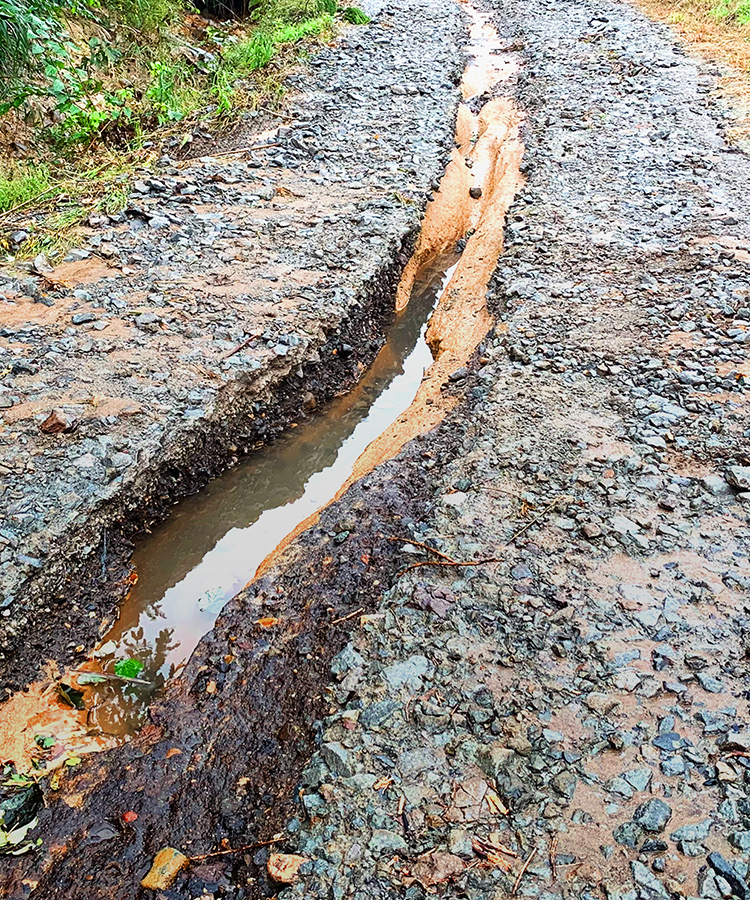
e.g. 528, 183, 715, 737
0, 3, 465, 692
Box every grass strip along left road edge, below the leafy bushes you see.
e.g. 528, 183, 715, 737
0, 0, 369, 262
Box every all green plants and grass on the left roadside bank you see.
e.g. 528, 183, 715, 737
0, 0, 369, 258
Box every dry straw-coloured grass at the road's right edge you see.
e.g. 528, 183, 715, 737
634, 0, 750, 141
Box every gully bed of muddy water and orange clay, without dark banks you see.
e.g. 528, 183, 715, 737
0, 3, 523, 765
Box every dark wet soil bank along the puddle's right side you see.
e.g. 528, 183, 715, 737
0, 398, 476, 898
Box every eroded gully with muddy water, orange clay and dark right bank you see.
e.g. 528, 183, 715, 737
0, 4, 523, 898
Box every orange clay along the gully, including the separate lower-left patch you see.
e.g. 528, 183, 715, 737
0, 6, 523, 769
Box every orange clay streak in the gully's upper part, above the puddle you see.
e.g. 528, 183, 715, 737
255, 6, 524, 577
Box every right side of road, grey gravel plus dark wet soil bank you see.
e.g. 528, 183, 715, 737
0, 0, 750, 900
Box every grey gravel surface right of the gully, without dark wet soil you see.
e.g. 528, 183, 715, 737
274, 0, 750, 900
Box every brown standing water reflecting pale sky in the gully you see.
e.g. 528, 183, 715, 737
79, 254, 457, 735
